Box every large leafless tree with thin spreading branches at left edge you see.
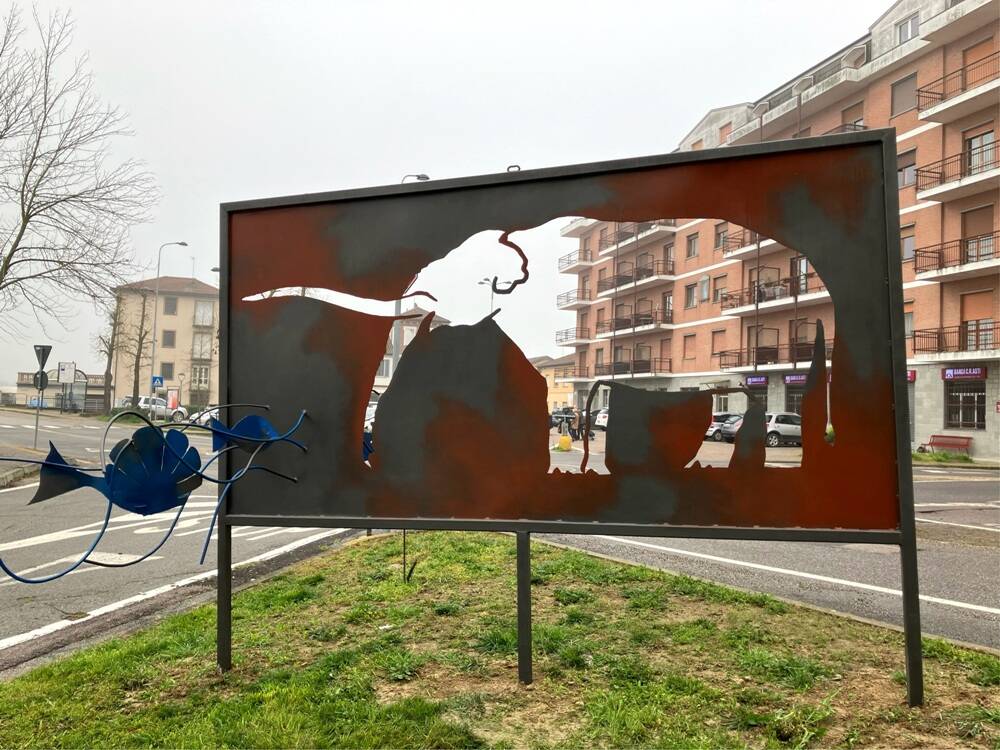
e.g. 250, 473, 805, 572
0, 8, 156, 335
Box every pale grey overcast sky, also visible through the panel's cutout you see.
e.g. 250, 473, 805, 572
0, 0, 889, 384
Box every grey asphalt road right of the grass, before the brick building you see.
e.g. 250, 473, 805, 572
545, 440, 1000, 649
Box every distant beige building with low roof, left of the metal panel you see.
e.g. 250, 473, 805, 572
112, 276, 219, 407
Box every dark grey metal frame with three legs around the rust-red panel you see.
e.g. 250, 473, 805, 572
217, 130, 923, 706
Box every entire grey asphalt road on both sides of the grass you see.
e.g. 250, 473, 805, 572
0, 410, 1000, 666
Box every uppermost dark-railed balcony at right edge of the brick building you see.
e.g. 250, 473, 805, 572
917, 52, 1000, 122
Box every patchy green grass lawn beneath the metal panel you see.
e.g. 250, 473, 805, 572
0, 532, 1000, 748
